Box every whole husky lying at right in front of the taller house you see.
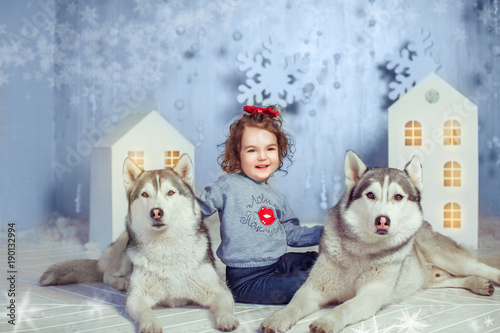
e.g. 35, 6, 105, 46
261, 151, 500, 333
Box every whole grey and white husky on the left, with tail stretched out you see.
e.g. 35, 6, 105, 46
40, 155, 238, 332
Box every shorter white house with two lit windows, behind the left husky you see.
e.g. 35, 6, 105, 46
89, 111, 194, 250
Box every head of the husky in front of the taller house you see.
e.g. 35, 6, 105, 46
344, 151, 423, 244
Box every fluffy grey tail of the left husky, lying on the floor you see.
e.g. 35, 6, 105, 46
40, 259, 103, 286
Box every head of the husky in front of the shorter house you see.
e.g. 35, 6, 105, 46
123, 154, 200, 237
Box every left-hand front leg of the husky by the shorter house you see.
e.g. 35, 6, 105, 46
125, 291, 162, 333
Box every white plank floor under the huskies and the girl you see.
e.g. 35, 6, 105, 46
0, 237, 500, 333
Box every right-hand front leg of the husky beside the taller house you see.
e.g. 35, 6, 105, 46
309, 282, 393, 333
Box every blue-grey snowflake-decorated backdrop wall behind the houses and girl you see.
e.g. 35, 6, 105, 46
0, 0, 500, 228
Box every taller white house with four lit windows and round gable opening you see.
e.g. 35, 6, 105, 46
388, 73, 478, 249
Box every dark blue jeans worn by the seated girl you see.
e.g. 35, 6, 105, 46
226, 251, 318, 304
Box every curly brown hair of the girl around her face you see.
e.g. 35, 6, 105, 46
217, 105, 294, 174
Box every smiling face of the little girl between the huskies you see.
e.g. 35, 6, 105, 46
240, 127, 280, 183
